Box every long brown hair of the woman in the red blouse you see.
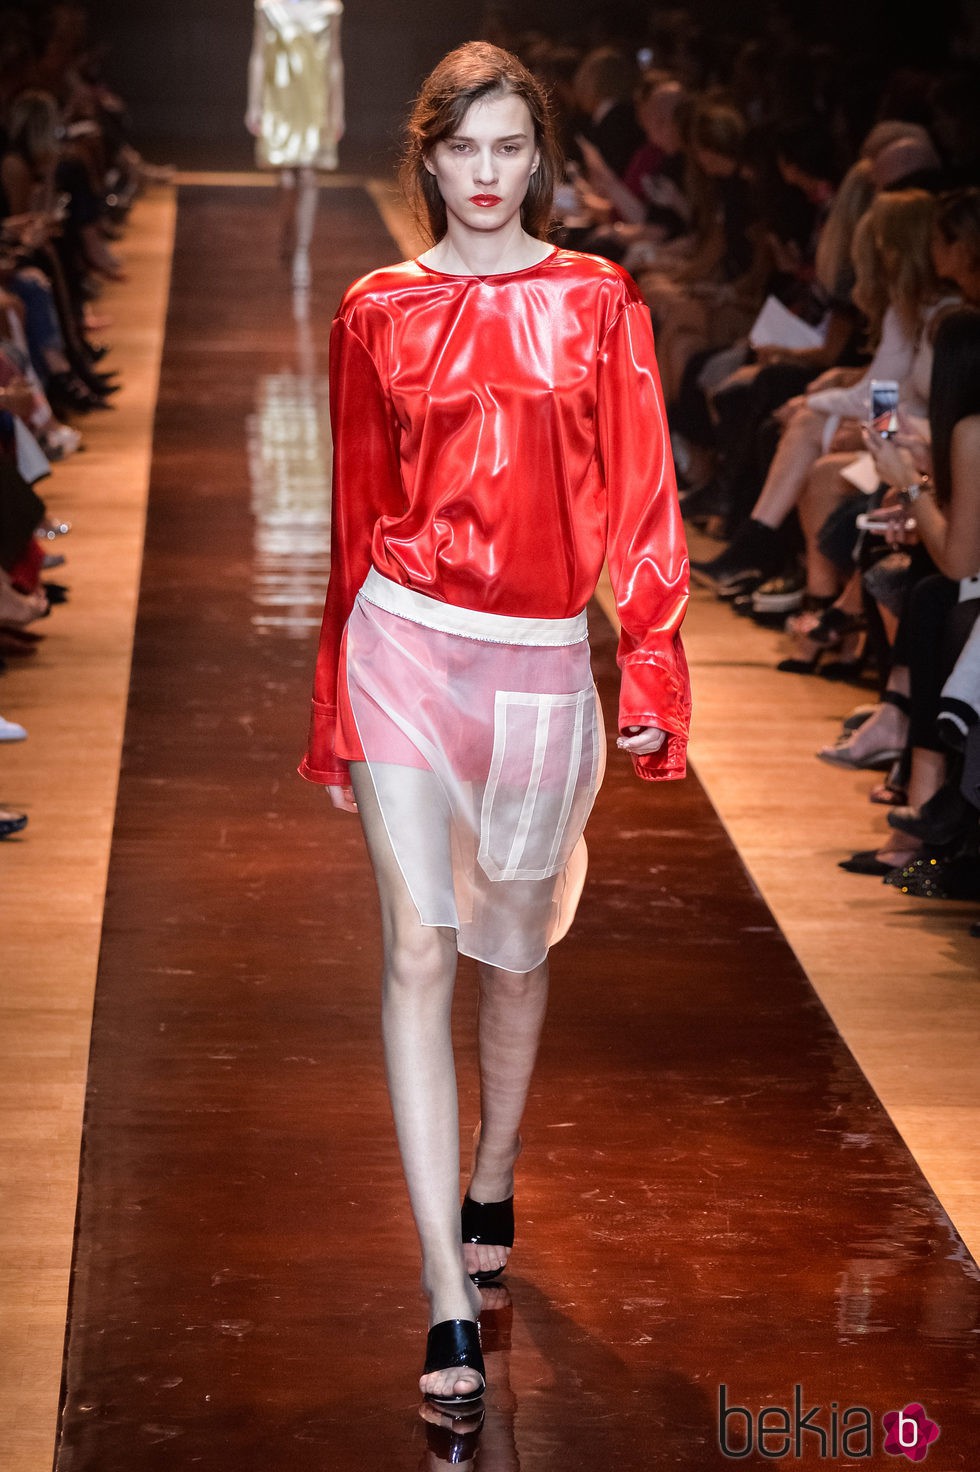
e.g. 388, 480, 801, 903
400, 41, 562, 240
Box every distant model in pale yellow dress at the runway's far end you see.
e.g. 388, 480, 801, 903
246, 0, 344, 290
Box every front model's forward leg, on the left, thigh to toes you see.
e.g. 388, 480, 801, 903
350, 762, 480, 1395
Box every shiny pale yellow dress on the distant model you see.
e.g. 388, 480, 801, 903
253, 0, 344, 169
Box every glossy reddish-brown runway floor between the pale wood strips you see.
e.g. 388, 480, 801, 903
56, 187, 980, 1472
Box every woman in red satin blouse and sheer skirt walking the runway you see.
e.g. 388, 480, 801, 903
300, 43, 690, 1407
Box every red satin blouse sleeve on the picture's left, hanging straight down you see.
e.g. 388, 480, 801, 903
299, 318, 402, 786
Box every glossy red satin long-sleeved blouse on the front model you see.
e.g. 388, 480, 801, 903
300, 249, 690, 785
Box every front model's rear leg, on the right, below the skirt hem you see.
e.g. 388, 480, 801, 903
464, 961, 547, 1273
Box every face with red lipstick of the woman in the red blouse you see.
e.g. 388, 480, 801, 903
425, 93, 539, 230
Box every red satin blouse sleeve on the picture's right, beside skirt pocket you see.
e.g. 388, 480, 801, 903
597, 300, 690, 782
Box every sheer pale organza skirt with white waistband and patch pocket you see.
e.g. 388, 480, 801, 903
344, 570, 605, 972
